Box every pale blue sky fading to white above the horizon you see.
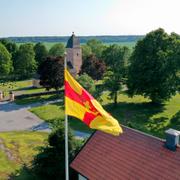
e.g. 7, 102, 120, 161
0, 0, 180, 37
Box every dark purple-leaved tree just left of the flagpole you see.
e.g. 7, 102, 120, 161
38, 57, 64, 90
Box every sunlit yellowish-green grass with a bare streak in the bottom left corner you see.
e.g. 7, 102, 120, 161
0, 132, 48, 179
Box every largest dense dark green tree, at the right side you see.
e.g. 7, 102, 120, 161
127, 29, 180, 103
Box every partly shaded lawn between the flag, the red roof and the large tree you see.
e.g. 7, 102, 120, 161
103, 94, 180, 138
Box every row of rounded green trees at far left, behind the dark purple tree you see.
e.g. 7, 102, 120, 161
0, 39, 65, 80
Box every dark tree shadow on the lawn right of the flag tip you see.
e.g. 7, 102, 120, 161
104, 102, 167, 136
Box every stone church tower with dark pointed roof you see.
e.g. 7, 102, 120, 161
66, 33, 82, 75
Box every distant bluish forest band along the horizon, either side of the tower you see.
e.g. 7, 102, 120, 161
3, 35, 144, 43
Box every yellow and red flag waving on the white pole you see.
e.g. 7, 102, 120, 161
65, 69, 122, 136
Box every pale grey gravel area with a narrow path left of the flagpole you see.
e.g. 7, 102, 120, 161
0, 100, 61, 132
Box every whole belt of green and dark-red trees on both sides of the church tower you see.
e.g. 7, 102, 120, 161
0, 28, 180, 104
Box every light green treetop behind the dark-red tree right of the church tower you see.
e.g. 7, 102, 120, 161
87, 39, 105, 59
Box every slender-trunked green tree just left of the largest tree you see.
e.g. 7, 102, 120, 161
102, 44, 129, 105
